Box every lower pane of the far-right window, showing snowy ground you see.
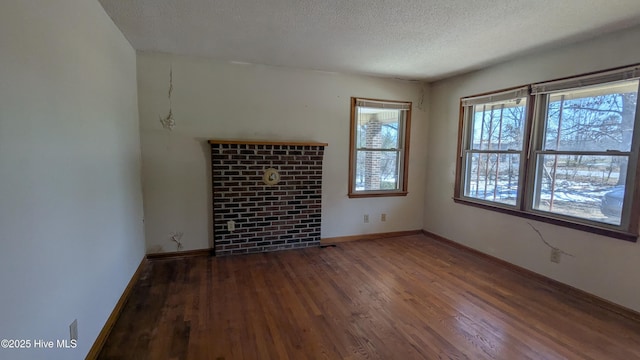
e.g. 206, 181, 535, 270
533, 154, 628, 225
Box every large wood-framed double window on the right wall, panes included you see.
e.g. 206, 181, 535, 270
455, 66, 640, 241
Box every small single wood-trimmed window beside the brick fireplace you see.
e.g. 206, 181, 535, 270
349, 98, 411, 197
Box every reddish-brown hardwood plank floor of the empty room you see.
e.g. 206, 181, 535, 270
99, 235, 640, 360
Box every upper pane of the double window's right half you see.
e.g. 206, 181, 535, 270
544, 80, 638, 151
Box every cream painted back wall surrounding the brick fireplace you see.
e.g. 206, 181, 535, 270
138, 52, 428, 253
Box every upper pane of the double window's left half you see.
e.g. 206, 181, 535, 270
471, 98, 527, 150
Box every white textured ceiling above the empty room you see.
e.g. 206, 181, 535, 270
99, 0, 640, 80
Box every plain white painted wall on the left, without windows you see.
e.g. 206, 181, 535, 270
0, 0, 144, 360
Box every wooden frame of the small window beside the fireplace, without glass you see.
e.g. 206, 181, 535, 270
347, 97, 412, 198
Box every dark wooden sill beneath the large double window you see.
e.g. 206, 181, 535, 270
453, 197, 638, 242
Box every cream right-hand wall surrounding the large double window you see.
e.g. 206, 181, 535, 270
424, 28, 640, 311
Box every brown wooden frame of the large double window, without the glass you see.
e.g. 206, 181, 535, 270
453, 64, 640, 242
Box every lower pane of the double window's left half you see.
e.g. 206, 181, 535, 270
465, 152, 520, 205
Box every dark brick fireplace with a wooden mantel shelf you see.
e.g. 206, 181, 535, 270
209, 140, 327, 256
